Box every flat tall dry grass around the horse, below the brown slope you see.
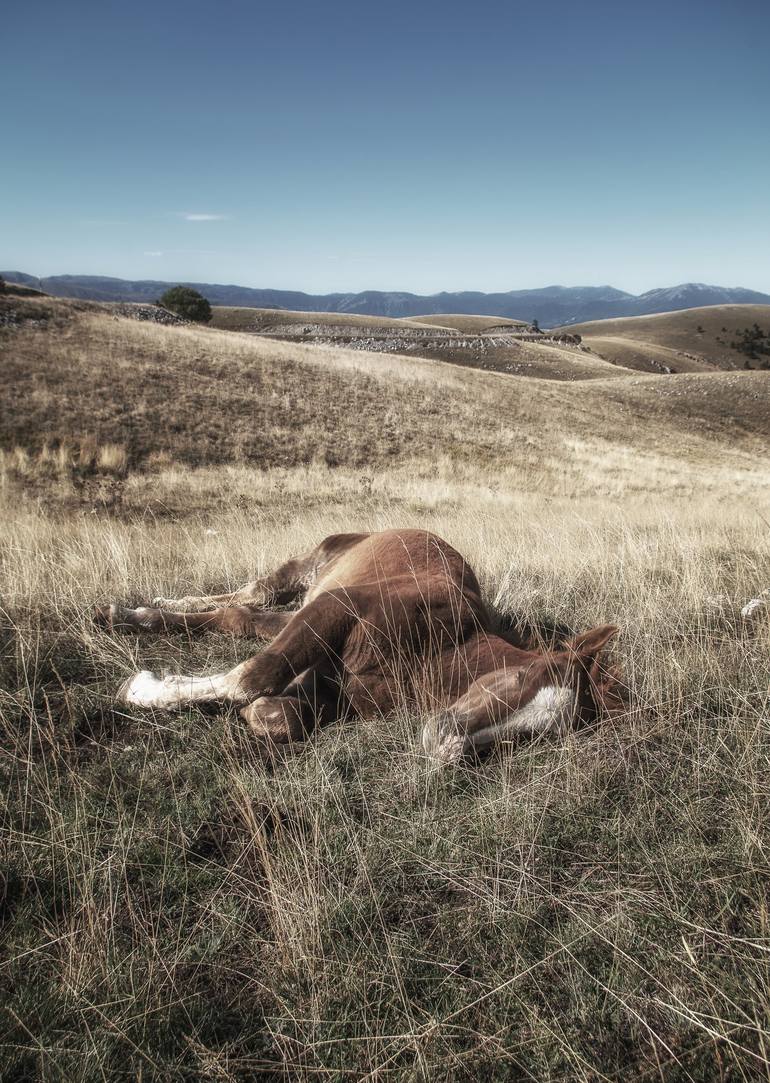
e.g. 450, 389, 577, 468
0, 464, 770, 1081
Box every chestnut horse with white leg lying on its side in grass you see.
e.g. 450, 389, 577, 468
96, 530, 619, 762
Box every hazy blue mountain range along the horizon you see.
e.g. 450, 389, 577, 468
0, 271, 770, 327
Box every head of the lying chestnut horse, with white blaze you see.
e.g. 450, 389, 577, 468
422, 625, 622, 764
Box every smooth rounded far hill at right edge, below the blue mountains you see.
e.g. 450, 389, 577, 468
564, 304, 770, 373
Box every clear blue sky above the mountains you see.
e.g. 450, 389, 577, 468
0, 0, 770, 292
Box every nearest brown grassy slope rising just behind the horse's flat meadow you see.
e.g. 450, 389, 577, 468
0, 299, 770, 492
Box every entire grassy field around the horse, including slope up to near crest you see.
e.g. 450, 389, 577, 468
0, 302, 770, 1083
